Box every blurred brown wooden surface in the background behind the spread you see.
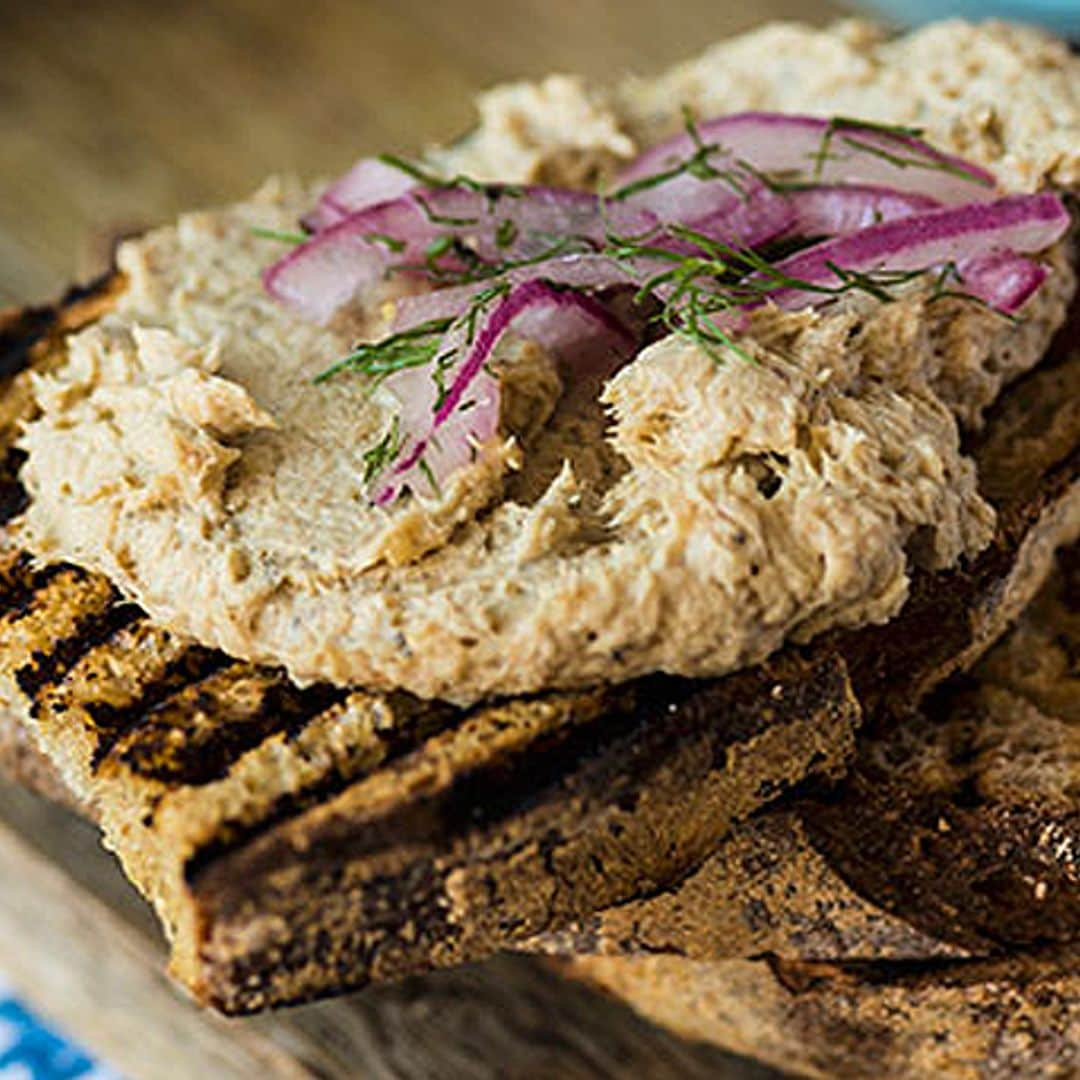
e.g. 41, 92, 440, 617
0, 0, 842, 306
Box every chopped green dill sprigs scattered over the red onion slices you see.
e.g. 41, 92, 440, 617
317, 117, 1011, 495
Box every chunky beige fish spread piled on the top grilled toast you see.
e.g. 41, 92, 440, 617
10, 24, 1080, 703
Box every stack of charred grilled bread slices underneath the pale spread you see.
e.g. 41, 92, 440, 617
0, 14, 1080, 1076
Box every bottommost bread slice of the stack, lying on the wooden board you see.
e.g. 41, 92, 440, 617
569, 946, 1080, 1080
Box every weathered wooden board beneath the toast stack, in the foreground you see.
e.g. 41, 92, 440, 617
0, 783, 775, 1080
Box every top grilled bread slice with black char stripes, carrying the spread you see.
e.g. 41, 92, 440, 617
0, 286, 1080, 1012
